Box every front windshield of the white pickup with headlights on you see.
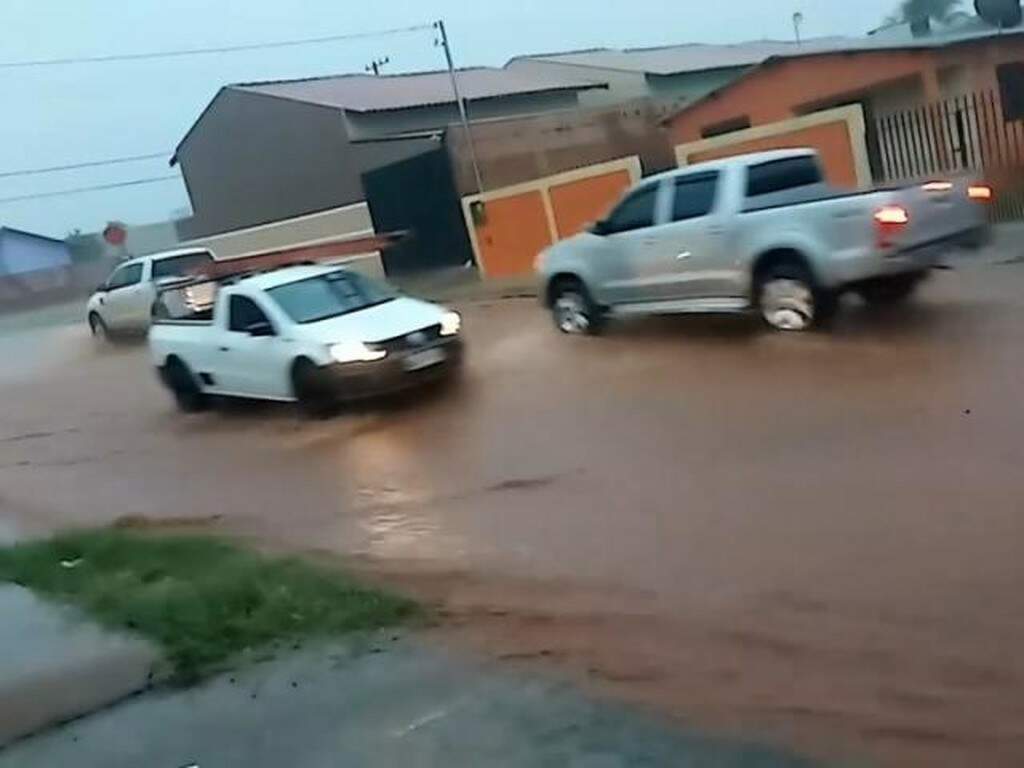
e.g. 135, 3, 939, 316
267, 269, 398, 325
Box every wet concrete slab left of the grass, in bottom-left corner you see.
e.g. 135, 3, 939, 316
0, 585, 160, 746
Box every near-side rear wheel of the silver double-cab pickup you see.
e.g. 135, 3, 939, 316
754, 259, 839, 332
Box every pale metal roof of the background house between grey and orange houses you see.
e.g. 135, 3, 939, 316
512, 37, 862, 75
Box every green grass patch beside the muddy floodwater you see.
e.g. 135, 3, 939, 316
0, 529, 416, 683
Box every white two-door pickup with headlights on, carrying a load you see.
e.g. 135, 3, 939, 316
150, 265, 463, 415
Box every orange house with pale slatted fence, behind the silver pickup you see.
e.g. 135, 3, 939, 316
665, 27, 1024, 191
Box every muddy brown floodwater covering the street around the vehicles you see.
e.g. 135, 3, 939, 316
0, 265, 1024, 767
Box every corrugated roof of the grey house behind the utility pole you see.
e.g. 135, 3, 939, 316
231, 68, 607, 112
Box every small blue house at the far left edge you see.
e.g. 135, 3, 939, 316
0, 226, 71, 304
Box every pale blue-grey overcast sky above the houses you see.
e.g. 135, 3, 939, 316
0, 0, 897, 237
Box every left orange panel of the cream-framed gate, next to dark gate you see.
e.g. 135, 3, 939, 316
476, 190, 551, 278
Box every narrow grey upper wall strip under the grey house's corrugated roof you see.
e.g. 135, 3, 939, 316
345, 91, 580, 139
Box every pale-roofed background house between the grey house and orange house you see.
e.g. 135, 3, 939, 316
506, 38, 851, 112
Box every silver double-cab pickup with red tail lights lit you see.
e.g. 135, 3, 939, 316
537, 150, 992, 333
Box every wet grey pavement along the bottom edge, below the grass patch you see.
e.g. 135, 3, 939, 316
0, 636, 811, 768
